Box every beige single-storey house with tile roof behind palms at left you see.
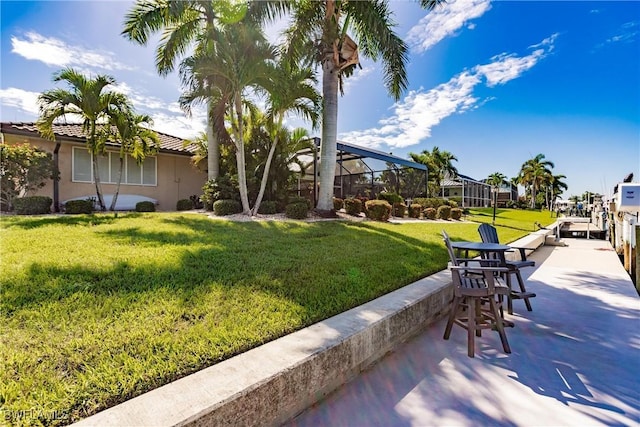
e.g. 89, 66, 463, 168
0, 122, 207, 212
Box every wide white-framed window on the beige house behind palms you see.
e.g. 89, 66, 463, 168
72, 147, 158, 186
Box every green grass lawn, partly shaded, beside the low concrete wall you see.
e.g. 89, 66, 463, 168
0, 210, 552, 425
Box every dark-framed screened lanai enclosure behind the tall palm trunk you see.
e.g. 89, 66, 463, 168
298, 138, 428, 205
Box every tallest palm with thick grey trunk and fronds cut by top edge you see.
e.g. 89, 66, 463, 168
286, 0, 442, 212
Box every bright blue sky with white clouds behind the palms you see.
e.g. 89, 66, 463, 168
0, 0, 640, 198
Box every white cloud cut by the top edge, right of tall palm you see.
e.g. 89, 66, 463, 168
406, 0, 491, 53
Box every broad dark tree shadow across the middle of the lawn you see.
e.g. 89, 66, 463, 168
1, 216, 447, 323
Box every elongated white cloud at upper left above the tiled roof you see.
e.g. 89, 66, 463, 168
11, 32, 134, 70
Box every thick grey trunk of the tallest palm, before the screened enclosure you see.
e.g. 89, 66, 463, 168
317, 59, 339, 212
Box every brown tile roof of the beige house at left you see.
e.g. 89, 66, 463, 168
2, 122, 195, 155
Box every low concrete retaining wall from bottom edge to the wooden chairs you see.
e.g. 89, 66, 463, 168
75, 270, 453, 426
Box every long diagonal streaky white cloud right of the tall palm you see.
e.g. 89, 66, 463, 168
340, 34, 557, 148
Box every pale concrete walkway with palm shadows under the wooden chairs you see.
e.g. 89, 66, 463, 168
290, 239, 640, 427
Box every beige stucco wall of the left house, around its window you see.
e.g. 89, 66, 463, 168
4, 134, 207, 211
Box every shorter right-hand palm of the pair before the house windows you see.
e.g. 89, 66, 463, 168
109, 111, 160, 211
